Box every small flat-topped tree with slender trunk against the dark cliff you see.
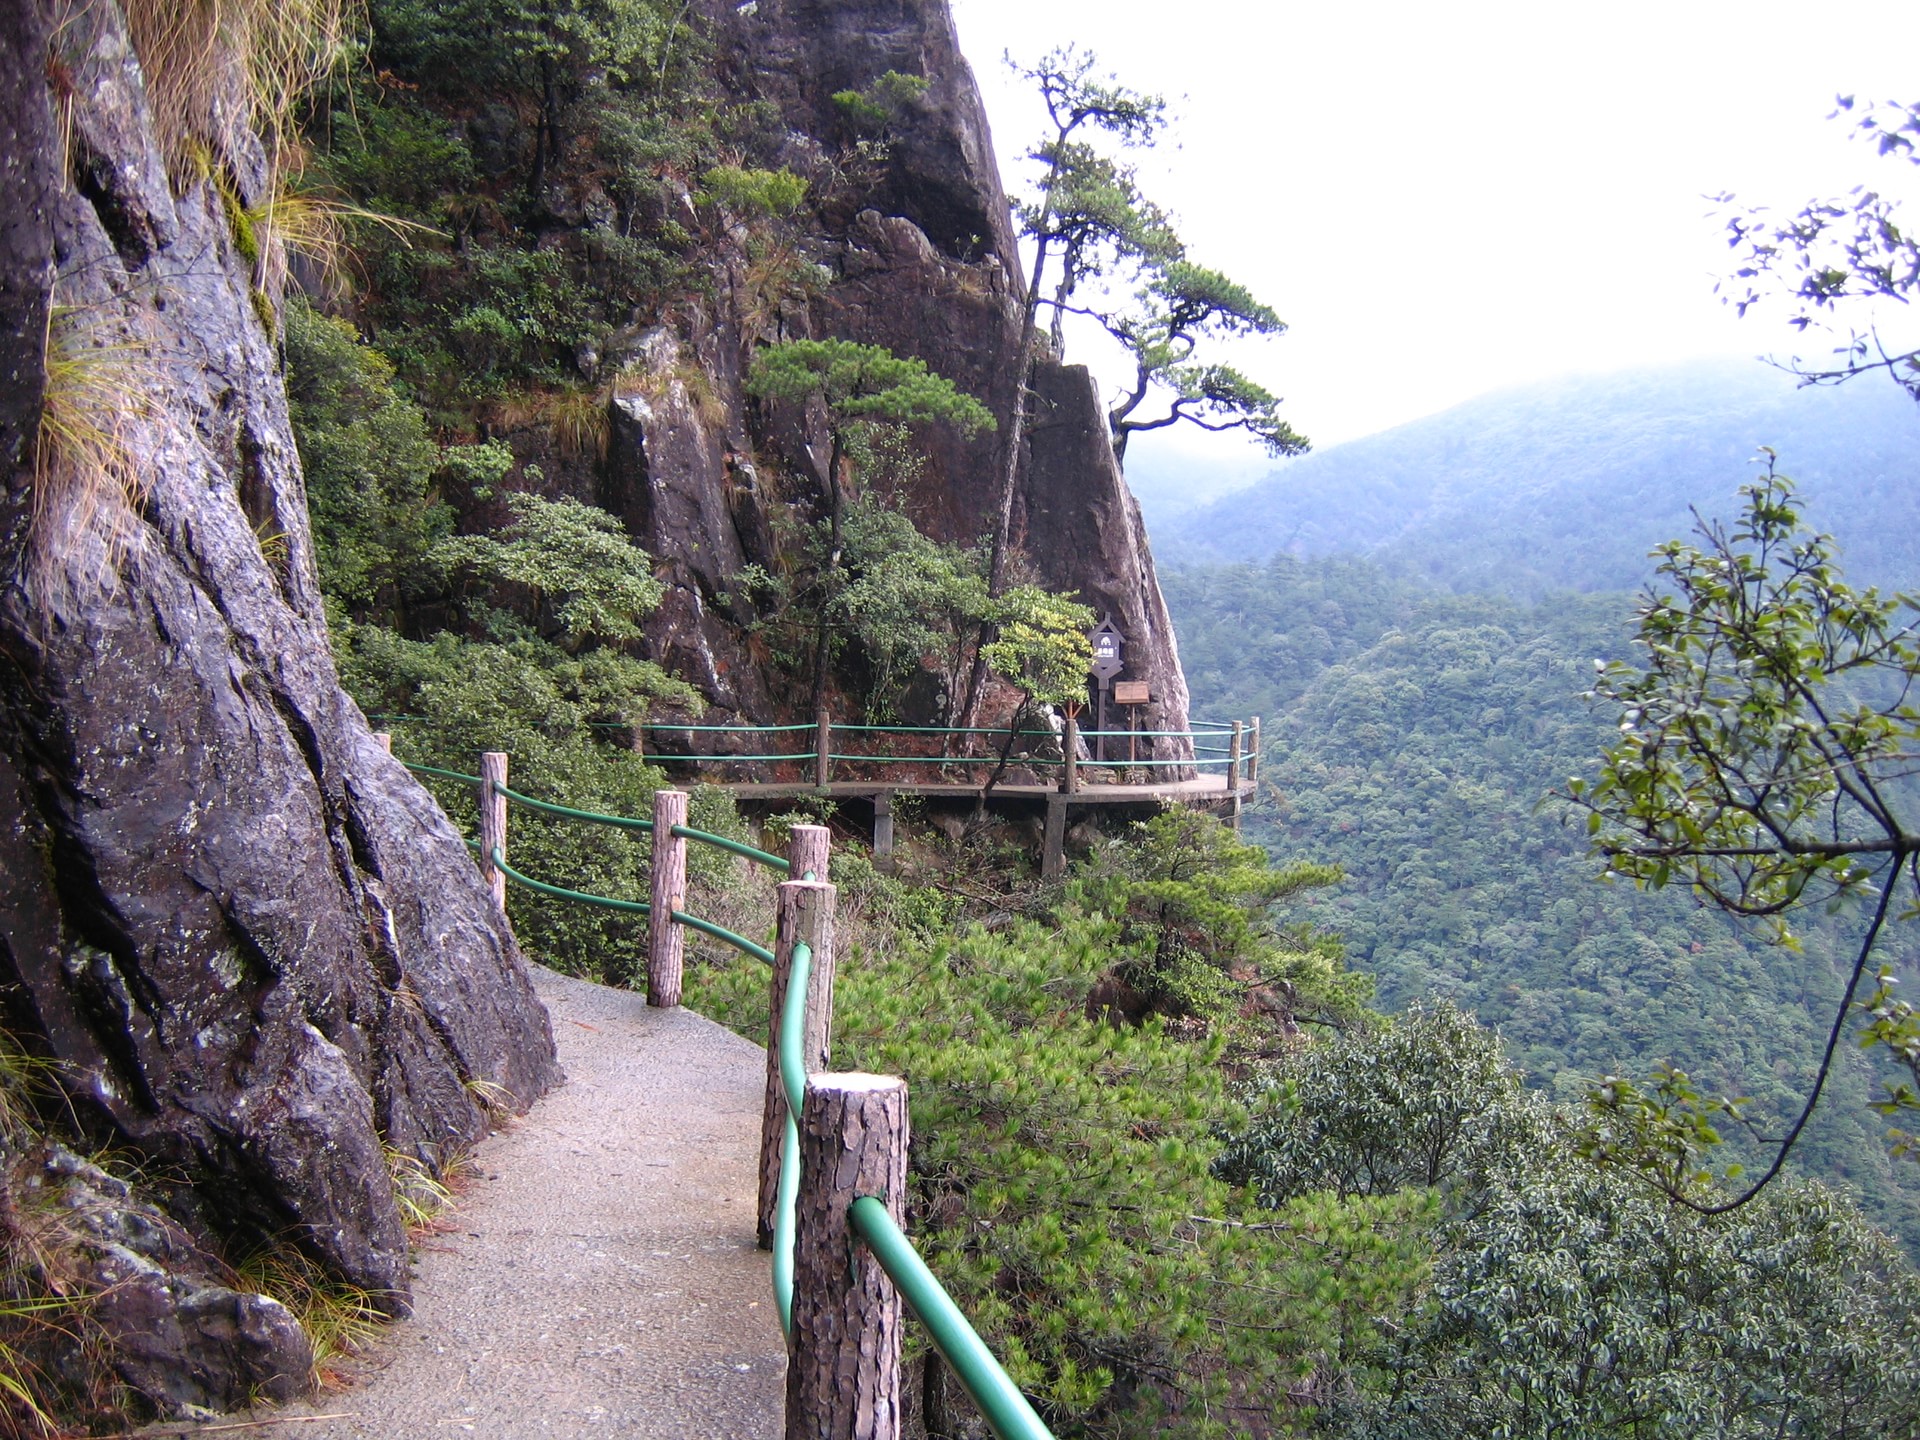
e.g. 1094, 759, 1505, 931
747, 340, 995, 705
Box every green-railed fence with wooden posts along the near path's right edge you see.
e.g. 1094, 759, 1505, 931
380, 753, 1054, 1440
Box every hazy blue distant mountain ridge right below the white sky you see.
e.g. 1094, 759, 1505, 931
1148, 359, 1920, 599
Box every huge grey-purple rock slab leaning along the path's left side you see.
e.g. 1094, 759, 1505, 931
0, 0, 559, 1309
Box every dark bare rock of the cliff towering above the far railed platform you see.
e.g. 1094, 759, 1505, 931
597, 0, 1190, 758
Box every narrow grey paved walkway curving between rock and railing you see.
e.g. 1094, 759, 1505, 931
222, 970, 785, 1440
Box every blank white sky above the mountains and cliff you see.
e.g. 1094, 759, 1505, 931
952, 0, 1920, 462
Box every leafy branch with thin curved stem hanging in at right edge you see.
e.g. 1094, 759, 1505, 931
1567, 468, 1920, 1213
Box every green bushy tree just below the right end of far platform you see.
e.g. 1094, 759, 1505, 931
1069, 808, 1371, 1023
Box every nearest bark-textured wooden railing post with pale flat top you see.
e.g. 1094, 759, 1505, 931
785, 1075, 906, 1440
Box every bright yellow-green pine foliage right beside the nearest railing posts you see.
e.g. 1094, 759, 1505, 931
687, 898, 1428, 1440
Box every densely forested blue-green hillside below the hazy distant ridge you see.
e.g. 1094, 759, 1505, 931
1167, 557, 1920, 1244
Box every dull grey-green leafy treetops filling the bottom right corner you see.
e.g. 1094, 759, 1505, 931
1217, 1006, 1920, 1440
